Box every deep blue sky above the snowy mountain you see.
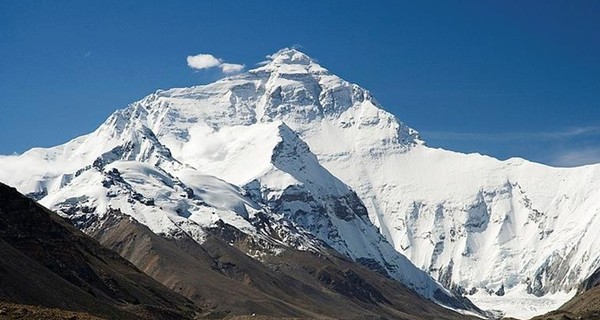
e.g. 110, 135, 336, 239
0, 0, 600, 165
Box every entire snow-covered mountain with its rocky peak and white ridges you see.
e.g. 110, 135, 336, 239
0, 49, 600, 316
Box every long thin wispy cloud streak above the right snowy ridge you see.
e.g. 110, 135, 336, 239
421, 126, 600, 142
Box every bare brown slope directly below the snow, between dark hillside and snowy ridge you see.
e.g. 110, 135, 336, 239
93, 211, 476, 319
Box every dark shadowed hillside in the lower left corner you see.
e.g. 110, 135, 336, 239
0, 184, 196, 319
